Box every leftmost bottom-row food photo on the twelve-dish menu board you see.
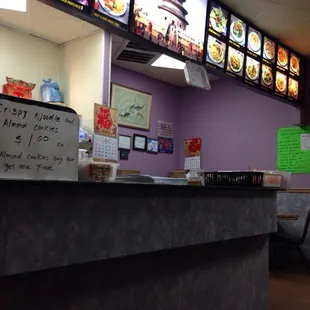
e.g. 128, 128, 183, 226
207, 35, 226, 68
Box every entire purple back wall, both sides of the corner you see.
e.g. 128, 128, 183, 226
111, 66, 310, 188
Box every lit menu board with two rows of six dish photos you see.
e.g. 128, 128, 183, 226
205, 0, 303, 104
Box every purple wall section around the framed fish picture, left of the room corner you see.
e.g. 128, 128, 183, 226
111, 66, 180, 176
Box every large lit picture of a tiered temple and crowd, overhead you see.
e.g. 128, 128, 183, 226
132, 0, 207, 62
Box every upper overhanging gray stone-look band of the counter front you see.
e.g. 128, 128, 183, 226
0, 181, 276, 275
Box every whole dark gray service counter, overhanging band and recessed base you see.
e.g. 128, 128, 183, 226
0, 181, 277, 310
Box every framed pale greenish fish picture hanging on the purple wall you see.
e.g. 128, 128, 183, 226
111, 83, 152, 131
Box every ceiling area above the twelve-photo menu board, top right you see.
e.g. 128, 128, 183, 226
221, 0, 310, 55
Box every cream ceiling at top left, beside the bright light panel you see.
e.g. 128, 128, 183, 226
0, 0, 99, 44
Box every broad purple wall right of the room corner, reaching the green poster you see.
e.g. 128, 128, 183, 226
178, 81, 310, 187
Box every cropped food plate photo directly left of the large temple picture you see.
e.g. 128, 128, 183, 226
94, 0, 130, 26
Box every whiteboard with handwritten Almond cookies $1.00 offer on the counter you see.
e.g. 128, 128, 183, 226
0, 96, 79, 181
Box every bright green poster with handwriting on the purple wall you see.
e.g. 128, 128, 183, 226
277, 127, 310, 173
